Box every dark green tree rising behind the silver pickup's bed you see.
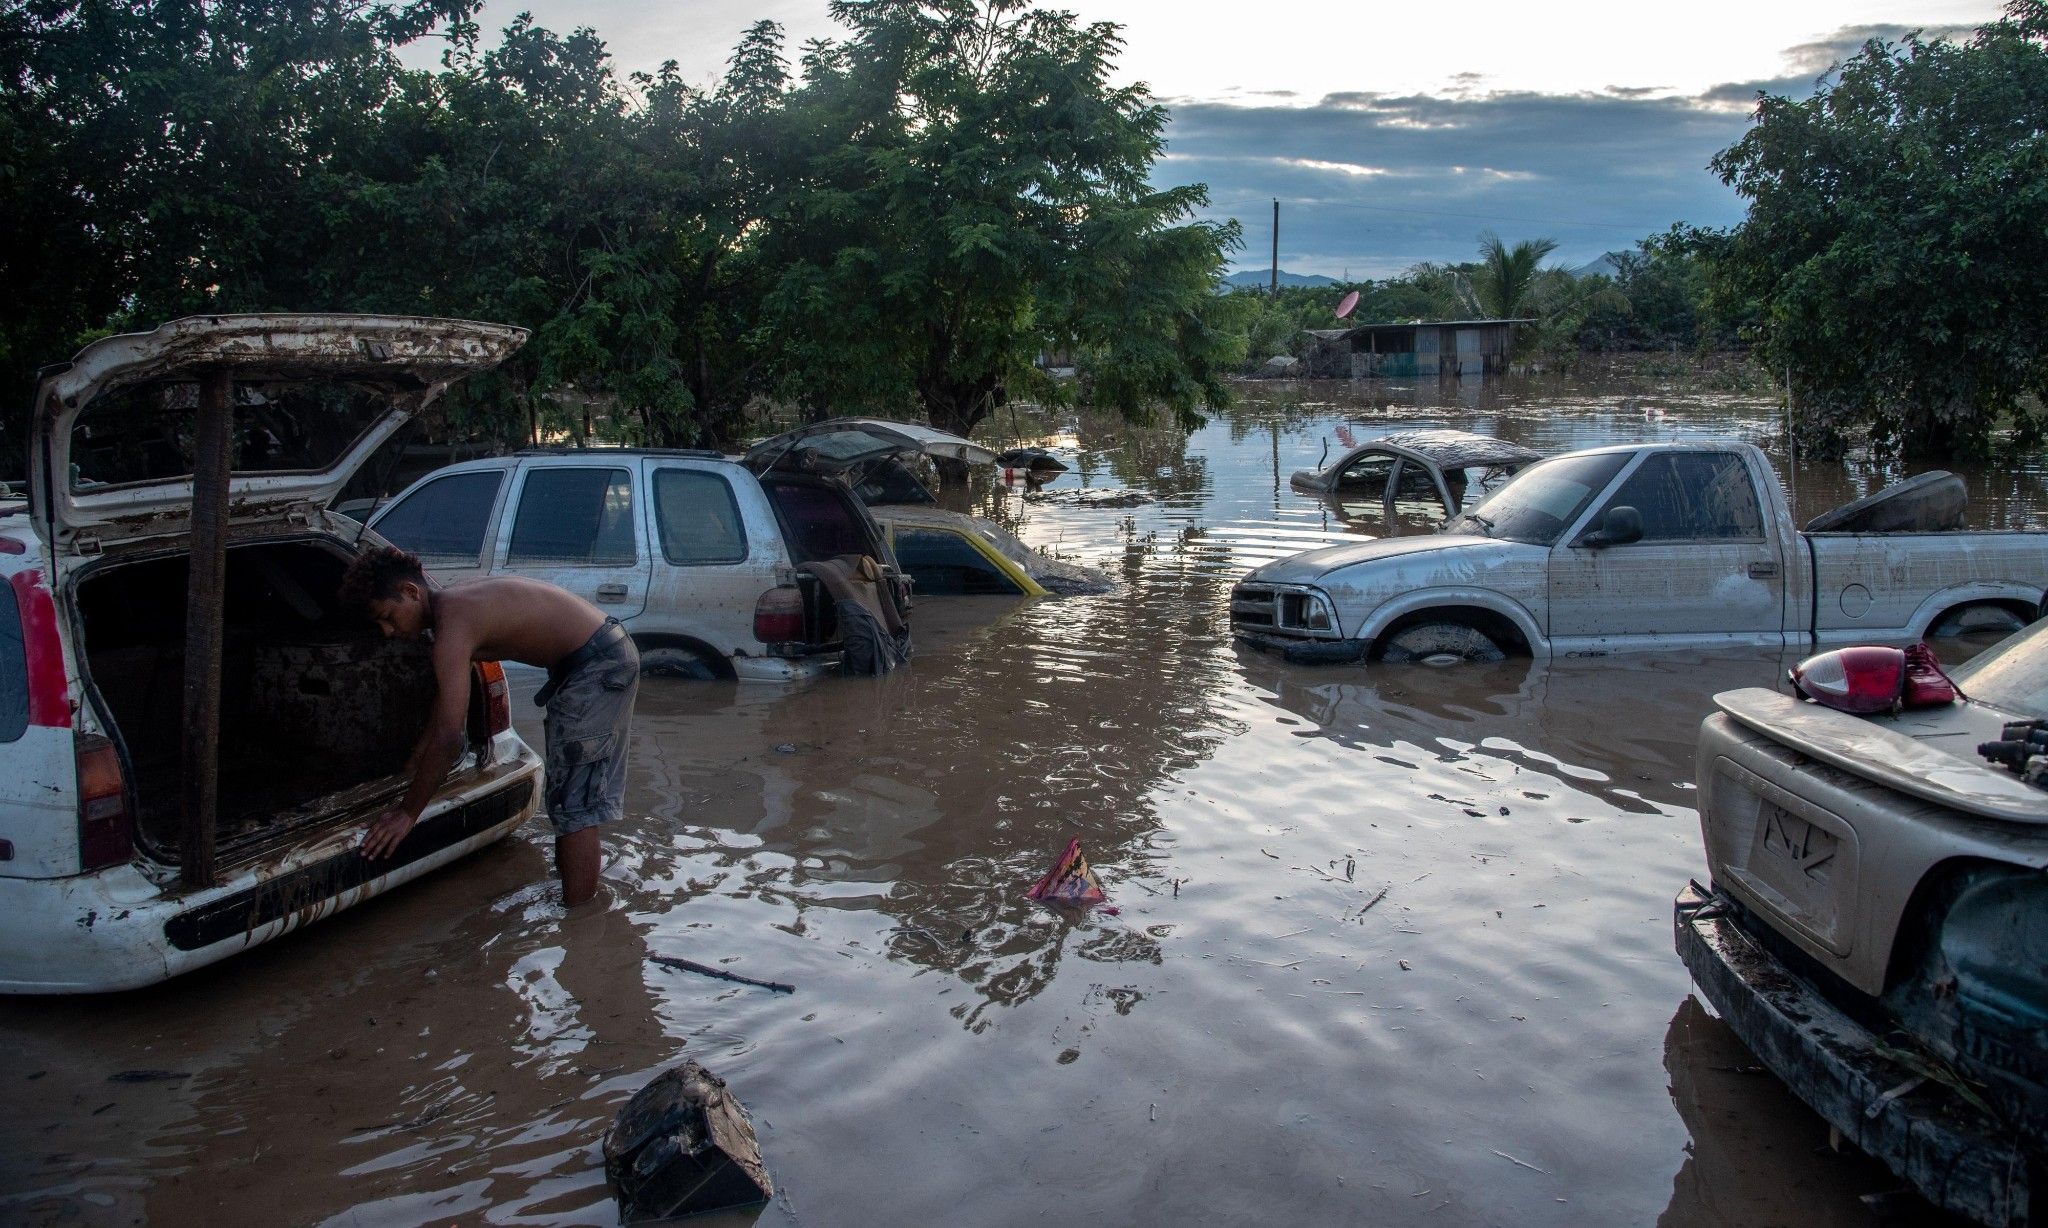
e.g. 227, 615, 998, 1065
1698, 0, 2048, 456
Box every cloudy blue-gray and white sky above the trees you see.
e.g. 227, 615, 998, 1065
444, 0, 2001, 276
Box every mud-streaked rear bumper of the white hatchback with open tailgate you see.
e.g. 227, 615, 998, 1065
0, 745, 541, 993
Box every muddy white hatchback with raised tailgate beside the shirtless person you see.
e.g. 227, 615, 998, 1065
0, 315, 541, 993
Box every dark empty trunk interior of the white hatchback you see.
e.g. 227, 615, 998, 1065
74, 538, 468, 862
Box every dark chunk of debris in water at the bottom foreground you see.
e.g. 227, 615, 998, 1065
604, 1062, 774, 1224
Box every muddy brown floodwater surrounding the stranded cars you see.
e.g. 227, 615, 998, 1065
0, 368, 2048, 1226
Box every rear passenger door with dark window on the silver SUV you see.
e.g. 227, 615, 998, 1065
492, 456, 651, 622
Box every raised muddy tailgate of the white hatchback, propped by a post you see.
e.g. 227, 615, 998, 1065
31, 315, 526, 549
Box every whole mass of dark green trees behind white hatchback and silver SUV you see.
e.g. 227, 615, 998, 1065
0, 0, 1241, 467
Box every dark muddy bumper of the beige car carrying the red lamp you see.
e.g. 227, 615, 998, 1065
1673, 884, 2048, 1228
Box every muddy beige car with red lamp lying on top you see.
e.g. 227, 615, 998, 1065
1673, 620, 2048, 1228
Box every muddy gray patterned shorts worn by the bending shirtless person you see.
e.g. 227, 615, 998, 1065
545, 622, 639, 835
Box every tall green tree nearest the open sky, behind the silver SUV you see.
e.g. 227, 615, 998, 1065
754, 0, 1241, 464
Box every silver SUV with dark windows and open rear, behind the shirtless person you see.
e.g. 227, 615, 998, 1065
371, 420, 989, 682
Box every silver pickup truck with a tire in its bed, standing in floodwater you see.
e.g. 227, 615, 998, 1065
1231, 442, 2048, 661
